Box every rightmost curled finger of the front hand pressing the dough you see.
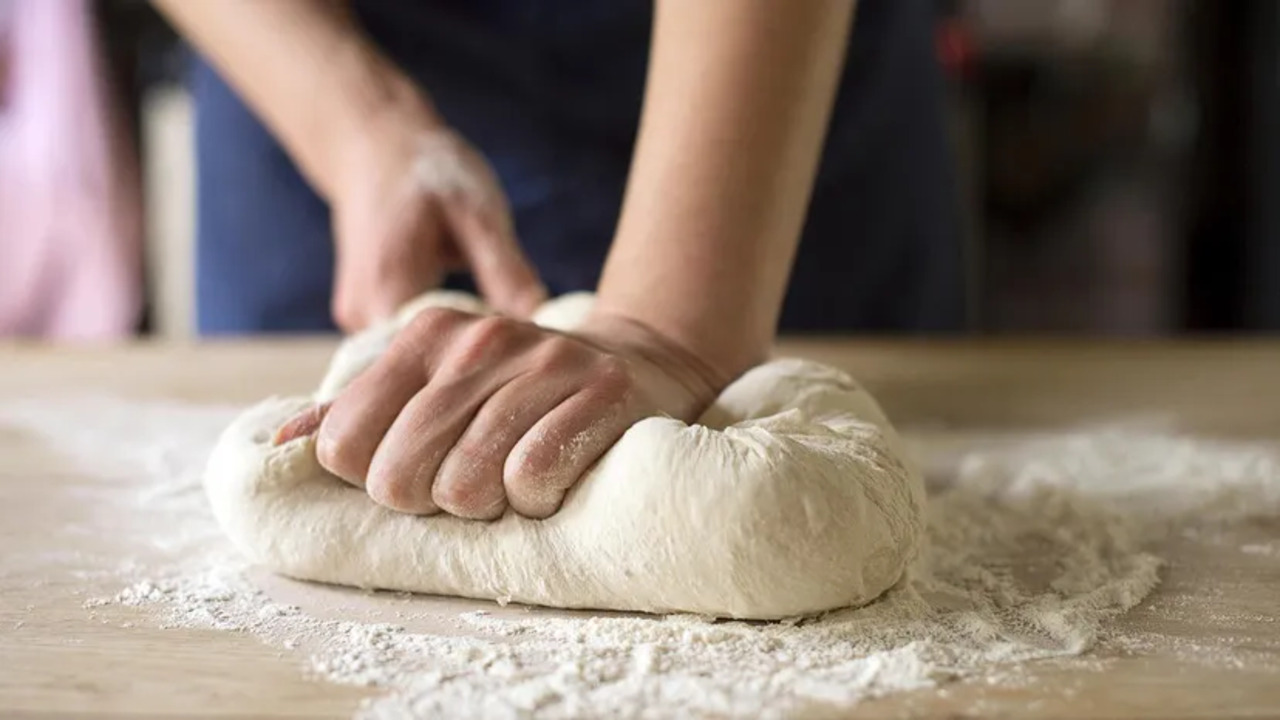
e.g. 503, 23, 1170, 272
503, 358, 640, 518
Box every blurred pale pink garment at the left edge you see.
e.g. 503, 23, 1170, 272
0, 0, 142, 340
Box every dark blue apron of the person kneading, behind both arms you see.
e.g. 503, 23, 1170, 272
192, 0, 964, 334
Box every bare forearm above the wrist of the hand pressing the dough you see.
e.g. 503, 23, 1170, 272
599, 0, 854, 375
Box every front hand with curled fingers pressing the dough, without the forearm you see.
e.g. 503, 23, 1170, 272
275, 309, 730, 519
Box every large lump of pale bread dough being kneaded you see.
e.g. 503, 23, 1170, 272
205, 293, 924, 619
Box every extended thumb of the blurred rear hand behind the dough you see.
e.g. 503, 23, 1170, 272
445, 204, 547, 318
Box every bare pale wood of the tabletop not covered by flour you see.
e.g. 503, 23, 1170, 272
0, 341, 1280, 717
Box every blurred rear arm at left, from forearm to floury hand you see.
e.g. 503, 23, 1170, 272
154, 0, 545, 325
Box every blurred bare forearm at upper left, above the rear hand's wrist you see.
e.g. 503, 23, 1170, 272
152, 0, 433, 197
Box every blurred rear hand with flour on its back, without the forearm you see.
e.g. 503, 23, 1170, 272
328, 106, 547, 332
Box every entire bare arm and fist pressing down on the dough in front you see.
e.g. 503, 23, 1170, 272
267, 0, 854, 519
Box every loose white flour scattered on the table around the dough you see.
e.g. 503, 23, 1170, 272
0, 398, 1280, 717
